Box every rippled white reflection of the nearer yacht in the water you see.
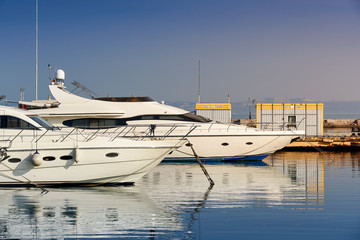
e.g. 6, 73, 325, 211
0, 187, 179, 239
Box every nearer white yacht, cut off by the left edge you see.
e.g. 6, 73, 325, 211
0, 106, 184, 186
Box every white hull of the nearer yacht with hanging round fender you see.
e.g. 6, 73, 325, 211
0, 139, 180, 186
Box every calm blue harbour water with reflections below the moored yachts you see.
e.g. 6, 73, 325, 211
0, 152, 360, 240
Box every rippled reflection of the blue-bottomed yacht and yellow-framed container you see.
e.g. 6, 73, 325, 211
138, 152, 324, 208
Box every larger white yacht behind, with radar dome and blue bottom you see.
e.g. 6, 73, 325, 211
19, 69, 304, 161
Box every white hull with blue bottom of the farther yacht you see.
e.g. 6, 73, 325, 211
164, 132, 297, 162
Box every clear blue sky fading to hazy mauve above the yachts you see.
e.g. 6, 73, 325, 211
0, 0, 360, 102
